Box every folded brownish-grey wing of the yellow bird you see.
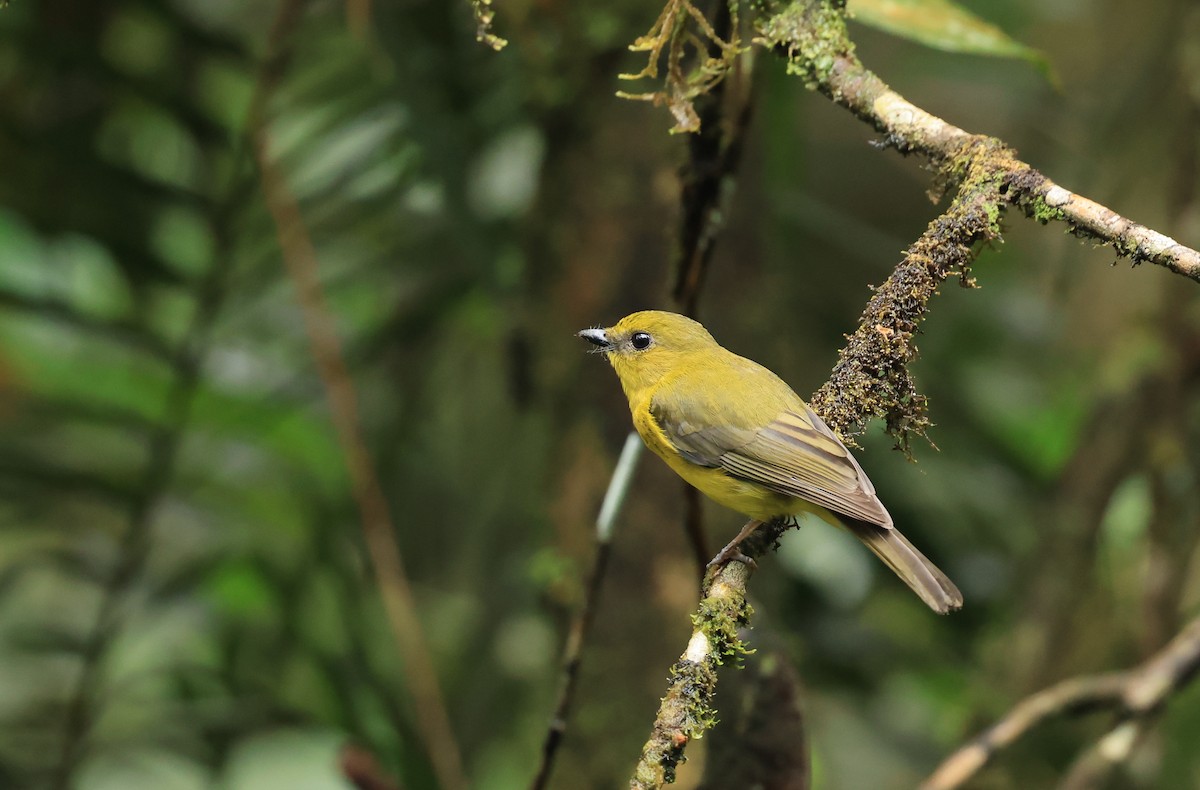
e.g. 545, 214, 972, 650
650, 400, 892, 527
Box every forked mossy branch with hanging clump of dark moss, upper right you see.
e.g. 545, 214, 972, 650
756, 0, 1200, 441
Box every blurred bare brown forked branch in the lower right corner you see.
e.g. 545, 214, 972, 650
920, 617, 1200, 790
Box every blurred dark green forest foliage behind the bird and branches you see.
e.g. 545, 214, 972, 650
0, 0, 1200, 790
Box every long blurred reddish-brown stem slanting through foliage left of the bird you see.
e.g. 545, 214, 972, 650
251, 0, 467, 790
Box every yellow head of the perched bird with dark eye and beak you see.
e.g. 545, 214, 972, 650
580, 310, 719, 397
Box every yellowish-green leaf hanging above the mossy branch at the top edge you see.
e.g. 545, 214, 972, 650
846, 0, 1057, 85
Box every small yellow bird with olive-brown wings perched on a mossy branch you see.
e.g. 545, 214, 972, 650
580, 310, 962, 615
